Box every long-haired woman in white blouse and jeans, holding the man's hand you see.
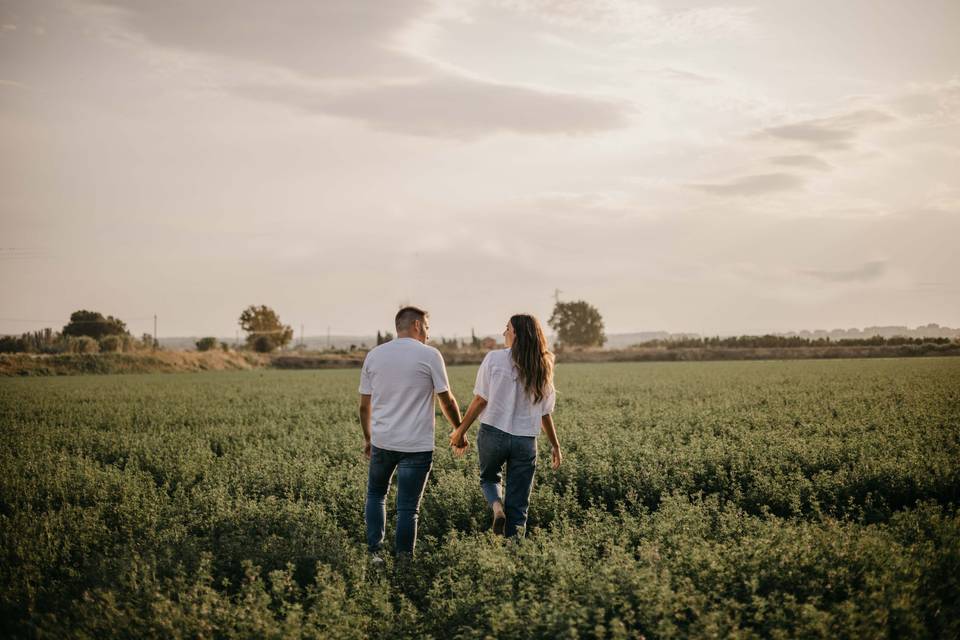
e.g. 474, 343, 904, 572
450, 314, 563, 537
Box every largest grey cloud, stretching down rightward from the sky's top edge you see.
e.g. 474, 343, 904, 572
92, 0, 628, 139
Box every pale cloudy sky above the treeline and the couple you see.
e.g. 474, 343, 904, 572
0, 0, 960, 336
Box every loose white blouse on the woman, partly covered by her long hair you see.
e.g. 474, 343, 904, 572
473, 349, 557, 436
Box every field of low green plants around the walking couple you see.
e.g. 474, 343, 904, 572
0, 358, 960, 639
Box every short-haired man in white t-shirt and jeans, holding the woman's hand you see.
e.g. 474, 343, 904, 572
360, 307, 460, 561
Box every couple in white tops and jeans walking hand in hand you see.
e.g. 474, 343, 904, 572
360, 307, 563, 559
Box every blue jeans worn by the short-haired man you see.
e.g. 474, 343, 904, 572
365, 446, 433, 555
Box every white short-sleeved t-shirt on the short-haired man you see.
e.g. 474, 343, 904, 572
360, 338, 450, 452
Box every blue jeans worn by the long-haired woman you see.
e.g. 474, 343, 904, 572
477, 423, 537, 537
